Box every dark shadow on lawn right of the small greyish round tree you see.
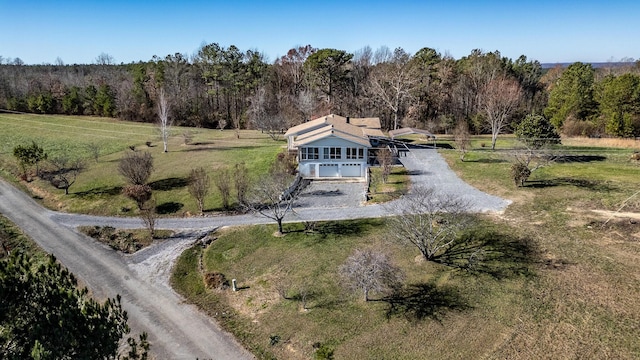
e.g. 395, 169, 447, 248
376, 283, 471, 321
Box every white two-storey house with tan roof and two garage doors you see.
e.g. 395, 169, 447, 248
285, 114, 385, 179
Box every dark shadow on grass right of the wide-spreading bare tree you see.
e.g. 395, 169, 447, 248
434, 230, 540, 279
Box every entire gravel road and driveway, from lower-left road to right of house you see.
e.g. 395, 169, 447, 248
0, 149, 510, 359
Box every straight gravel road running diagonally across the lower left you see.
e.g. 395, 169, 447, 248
0, 180, 253, 359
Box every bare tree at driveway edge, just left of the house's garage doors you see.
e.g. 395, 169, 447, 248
244, 171, 303, 234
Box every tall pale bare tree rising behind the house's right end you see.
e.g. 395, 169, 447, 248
369, 47, 415, 129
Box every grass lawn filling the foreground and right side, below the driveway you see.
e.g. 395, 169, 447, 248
173, 136, 640, 359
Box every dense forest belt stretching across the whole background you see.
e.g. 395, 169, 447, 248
0, 43, 640, 137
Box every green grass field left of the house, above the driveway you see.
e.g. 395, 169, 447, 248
0, 114, 284, 216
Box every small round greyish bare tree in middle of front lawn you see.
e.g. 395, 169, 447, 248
339, 250, 404, 301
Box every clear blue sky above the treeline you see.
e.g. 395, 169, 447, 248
0, 0, 640, 64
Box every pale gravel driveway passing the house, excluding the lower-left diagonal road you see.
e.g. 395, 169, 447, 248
50, 149, 511, 229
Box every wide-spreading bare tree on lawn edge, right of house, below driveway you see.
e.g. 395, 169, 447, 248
389, 186, 471, 262
